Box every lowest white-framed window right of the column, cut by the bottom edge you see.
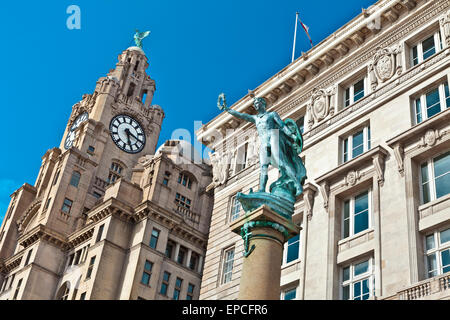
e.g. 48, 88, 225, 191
341, 259, 374, 300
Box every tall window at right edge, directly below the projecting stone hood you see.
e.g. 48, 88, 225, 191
420, 151, 450, 204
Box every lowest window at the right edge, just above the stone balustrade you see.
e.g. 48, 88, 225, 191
425, 228, 450, 278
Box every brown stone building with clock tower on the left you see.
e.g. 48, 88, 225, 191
0, 43, 213, 300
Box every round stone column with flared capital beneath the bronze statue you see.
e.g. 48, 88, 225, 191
230, 205, 300, 300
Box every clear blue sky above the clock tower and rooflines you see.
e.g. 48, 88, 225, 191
0, 0, 375, 221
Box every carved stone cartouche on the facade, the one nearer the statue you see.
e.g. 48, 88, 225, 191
308, 88, 335, 128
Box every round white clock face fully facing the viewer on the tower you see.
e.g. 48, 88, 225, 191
109, 114, 145, 153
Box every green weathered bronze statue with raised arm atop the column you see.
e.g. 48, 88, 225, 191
217, 93, 306, 220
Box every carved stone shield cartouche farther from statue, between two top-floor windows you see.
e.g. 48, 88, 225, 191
369, 46, 402, 90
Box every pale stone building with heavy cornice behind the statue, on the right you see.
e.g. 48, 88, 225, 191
197, 0, 450, 299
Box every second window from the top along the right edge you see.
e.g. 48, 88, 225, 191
413, 81, 450, 124
